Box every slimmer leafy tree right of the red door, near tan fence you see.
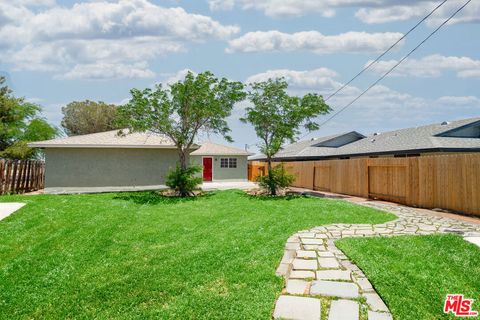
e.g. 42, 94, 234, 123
240, 78, 331, 195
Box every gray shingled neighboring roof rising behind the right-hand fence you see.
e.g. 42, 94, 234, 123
264, 117, 480, 159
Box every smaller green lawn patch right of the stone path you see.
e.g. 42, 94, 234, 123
336, 235, 480, 320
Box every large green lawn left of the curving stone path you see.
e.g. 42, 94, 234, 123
0, 191, 394, 319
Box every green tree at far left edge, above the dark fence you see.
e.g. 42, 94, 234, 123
0, 77, 58, 159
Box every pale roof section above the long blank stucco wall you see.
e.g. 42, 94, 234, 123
28, 129, 188, 149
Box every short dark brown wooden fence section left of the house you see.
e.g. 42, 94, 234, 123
0, 159, 45, 194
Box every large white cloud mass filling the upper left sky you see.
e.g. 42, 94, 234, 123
0, 0, 239, 78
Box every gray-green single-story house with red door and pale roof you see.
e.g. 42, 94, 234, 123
29, 130, 249, 193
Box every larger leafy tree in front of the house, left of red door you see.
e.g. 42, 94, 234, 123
120, 71, 246, 196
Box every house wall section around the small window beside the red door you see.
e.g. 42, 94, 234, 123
190, 156, 248, 181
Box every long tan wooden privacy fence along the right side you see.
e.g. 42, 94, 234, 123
250, 153, 480, 216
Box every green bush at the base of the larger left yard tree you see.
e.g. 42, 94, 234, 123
166, 164, 203, 197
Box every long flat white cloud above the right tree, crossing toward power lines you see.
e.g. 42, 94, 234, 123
226, 31, 402, 54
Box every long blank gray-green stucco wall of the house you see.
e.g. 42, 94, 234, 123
45, 148, 178, 188
